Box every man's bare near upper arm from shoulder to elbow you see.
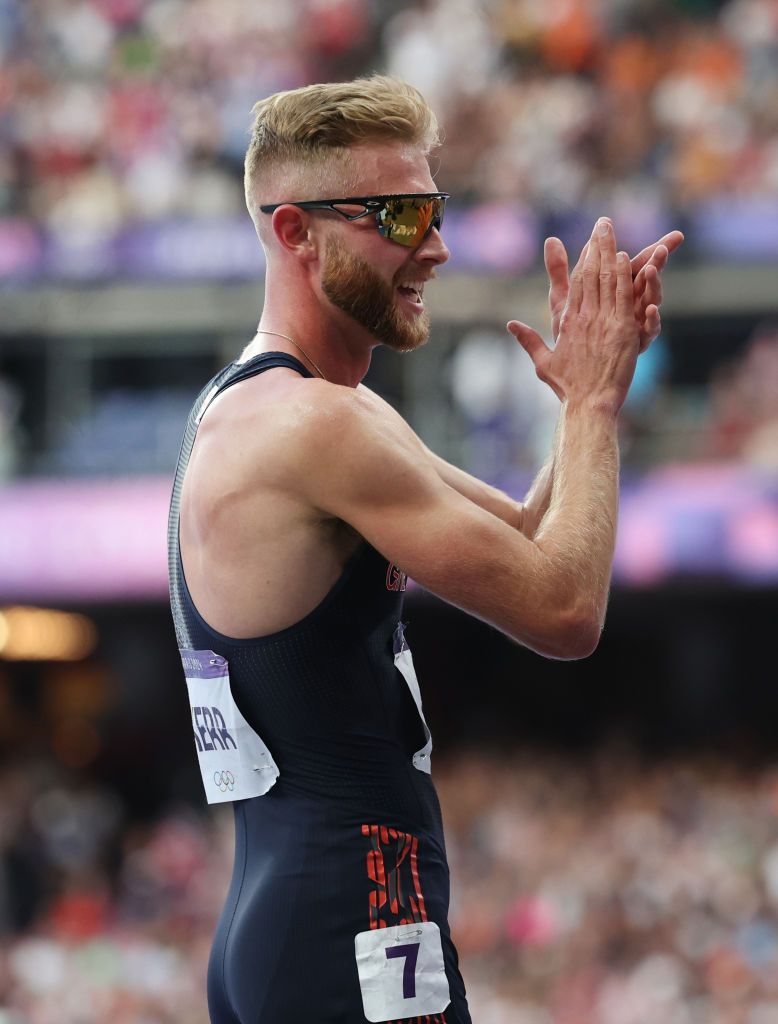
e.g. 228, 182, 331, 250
296, 397, 555, 652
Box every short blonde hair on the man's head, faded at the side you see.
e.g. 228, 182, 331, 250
244, 75, 439, 223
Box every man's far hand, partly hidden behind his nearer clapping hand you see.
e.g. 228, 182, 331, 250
544, 222, 684, 352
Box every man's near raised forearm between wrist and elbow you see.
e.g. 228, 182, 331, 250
533, 403, 619, 626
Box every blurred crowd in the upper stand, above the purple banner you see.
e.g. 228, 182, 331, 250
0, 0, 778, 236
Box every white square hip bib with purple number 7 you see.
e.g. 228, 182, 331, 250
354, 921, 451, 1021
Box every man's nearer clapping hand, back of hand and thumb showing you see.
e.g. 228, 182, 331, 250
508, 217, 642, 415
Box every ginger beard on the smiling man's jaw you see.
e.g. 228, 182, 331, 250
321, 238, 430, 352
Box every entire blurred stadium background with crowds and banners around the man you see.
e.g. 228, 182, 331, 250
0, 0, 778, 1024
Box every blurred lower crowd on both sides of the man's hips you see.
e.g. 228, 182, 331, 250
0, 749, 778, 1024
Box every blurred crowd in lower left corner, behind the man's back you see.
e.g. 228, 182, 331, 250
0, 761, 225, 1024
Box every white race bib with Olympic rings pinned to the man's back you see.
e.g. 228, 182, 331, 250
180, 649, 278, 804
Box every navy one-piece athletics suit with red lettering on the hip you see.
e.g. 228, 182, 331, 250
169, 352, 471, 1024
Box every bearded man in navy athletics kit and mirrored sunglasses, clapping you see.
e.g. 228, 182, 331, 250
170, 77, 681, 1024
